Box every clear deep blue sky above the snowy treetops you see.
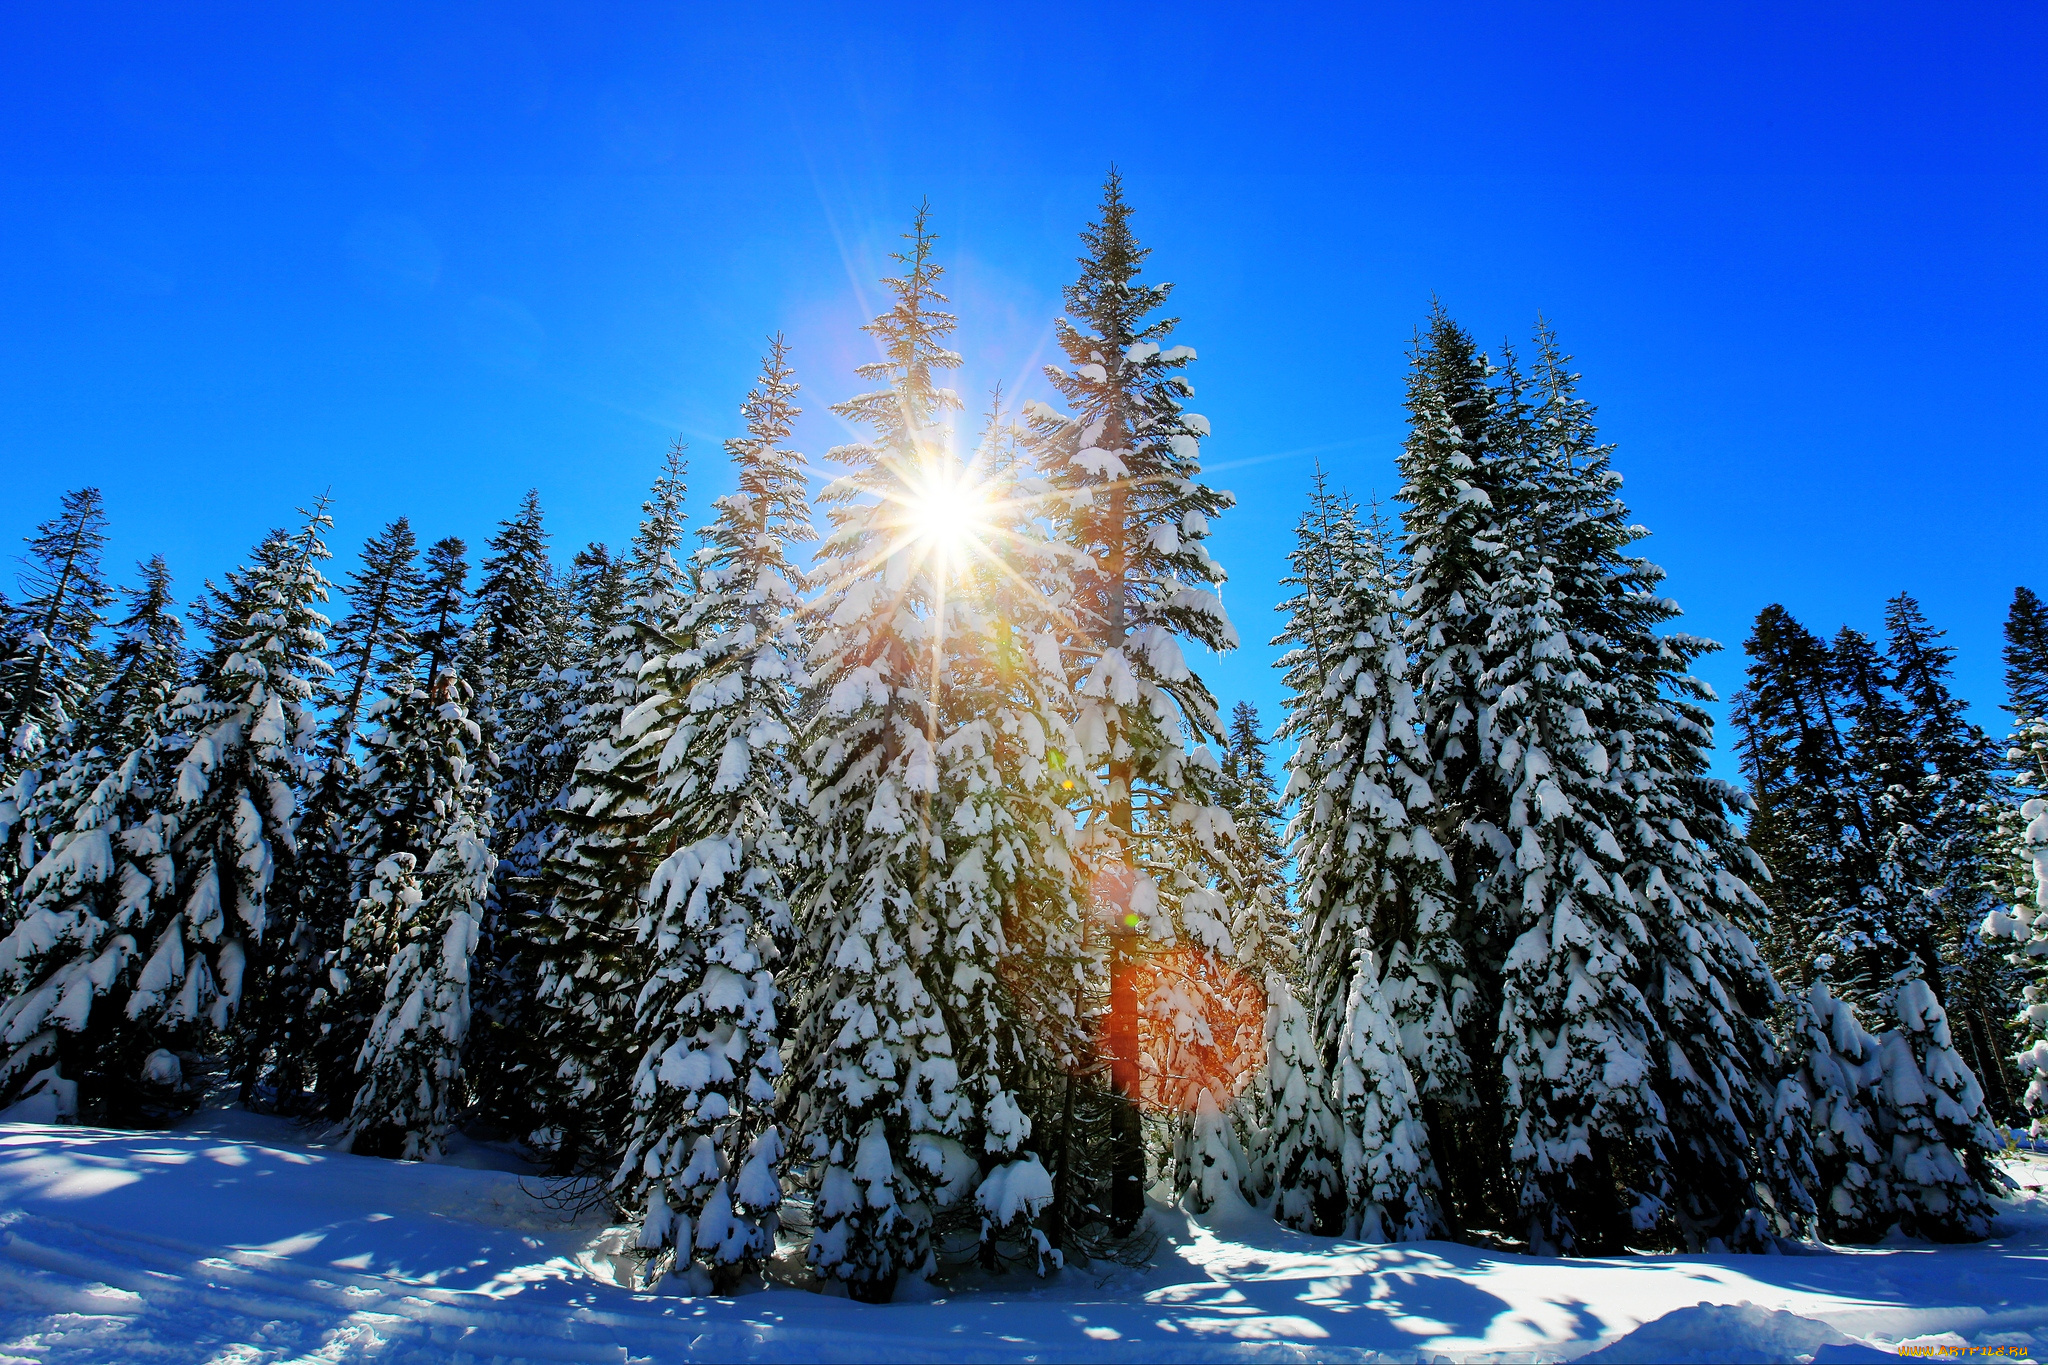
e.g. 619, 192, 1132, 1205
0, 4, 2048, 773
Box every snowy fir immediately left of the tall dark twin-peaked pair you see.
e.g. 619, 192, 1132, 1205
1268, 480, 1460, 1238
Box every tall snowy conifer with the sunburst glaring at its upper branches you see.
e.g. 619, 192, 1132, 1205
791, 209, 975, 1302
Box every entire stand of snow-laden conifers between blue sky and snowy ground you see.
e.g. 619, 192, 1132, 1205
0, 174, 2048, 1302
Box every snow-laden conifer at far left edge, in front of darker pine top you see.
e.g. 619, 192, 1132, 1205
0, 557, 184, 1121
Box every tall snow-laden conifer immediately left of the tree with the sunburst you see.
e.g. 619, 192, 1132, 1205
614, 356, 813, 1291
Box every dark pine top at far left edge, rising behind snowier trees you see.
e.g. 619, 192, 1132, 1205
0, 487, 115, 780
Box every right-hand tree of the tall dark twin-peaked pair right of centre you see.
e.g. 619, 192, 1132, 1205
1503, 327, 1792, 1246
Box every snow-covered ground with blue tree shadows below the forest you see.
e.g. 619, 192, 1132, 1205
0, 1111, 2048, 1363
